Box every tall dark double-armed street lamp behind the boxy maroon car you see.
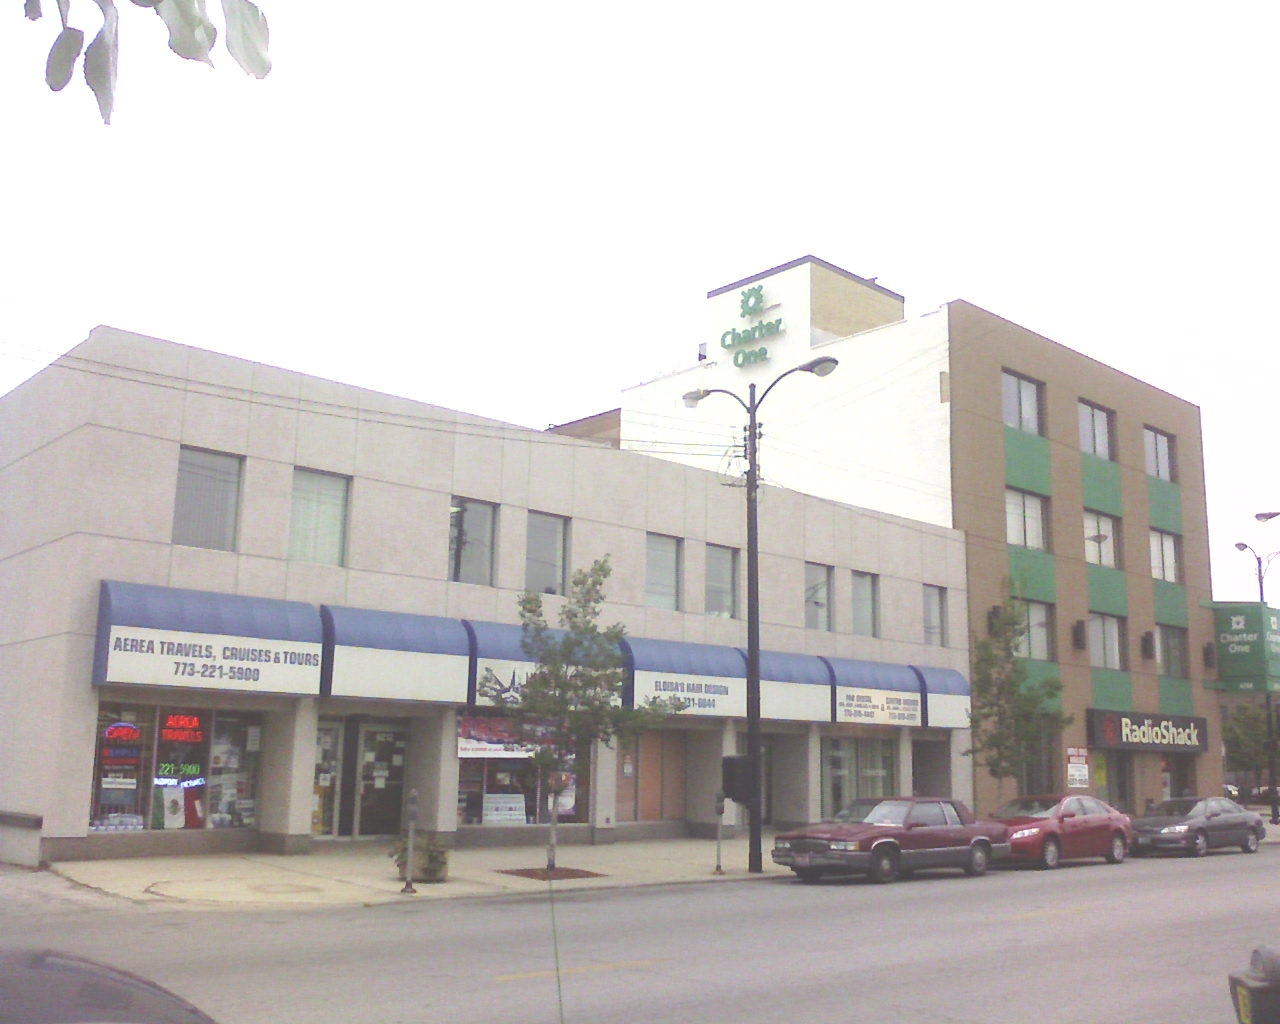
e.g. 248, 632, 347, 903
685, 356, 840, 874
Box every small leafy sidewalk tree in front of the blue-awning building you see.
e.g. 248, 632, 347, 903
479, 557, 680, 870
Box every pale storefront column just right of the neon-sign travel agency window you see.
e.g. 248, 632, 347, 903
259, 698, 320, 854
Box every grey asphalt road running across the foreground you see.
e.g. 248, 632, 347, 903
0, 846, 1280, 1024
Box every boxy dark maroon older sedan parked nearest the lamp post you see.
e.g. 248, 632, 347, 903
773, 796, 1009, 882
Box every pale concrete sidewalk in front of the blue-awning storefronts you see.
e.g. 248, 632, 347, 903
42, 836, 790, 909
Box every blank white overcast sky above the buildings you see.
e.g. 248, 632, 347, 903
0, 0, 1280, 604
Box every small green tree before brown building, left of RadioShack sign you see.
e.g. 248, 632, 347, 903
964, 596, 1071, 804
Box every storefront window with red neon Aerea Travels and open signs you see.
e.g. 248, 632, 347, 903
90, 704, 262, 832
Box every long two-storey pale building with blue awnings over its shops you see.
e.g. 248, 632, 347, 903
0, 322, 973, 864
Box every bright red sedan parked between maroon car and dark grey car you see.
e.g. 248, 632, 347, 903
992, 794, 1133, 868
